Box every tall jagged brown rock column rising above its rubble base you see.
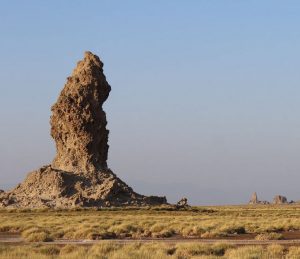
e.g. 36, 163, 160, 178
50, 52, 111, 173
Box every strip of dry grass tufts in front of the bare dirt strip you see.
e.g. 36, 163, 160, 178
0, 241, 300, 259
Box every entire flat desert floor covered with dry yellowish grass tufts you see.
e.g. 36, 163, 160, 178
0, 204, 300, 259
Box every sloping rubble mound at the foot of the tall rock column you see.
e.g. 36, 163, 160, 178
0, 165, 167, 208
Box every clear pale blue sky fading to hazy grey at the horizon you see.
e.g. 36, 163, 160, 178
0, 0, 300, 204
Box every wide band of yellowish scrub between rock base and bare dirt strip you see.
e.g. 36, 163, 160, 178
0, 205, 300, 242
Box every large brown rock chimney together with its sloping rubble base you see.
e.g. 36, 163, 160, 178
0, 52, 167, 208
